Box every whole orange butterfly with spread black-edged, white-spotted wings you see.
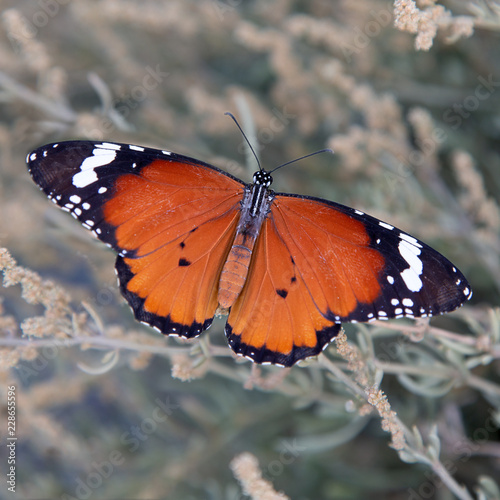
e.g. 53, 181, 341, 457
26, 137, 472, 366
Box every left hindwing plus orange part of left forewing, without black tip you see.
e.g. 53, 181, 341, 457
103, 161, 242, 337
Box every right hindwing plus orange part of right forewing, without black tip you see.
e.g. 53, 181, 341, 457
226, 195, 385, 366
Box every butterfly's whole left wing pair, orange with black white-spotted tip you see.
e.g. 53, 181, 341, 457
27, 141, 243, 337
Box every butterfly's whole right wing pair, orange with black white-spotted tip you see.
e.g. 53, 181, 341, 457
226, 193, 471, 366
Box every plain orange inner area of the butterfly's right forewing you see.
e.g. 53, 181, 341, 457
272, 196, 385, 319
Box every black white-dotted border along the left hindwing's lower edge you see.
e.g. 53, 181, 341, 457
115, 256, 213, 339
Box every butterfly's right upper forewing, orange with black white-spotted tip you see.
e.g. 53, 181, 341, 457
272, 195, 471, 322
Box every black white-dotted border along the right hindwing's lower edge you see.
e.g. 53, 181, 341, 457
226, 323, 342, 367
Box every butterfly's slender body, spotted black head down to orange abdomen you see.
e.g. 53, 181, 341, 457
218, 177, 275, 314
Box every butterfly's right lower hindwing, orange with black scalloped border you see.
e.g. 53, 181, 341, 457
226, 211, 340, 366
